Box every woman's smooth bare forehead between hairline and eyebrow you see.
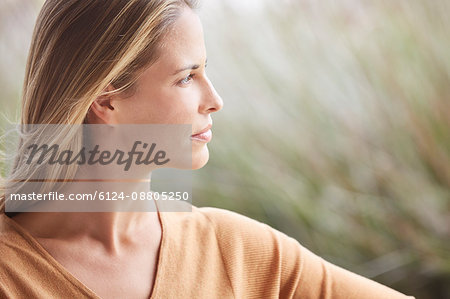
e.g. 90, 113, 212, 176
157, 8, 206, 68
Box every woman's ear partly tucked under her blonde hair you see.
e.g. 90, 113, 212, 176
86, 84, 117, 124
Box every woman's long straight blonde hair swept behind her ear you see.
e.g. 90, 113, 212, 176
0, 0, 197, 216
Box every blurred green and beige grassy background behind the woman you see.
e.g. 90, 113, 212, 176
0, 0, 450, 298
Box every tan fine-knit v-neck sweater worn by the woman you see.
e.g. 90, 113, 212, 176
0, 206, 413, 299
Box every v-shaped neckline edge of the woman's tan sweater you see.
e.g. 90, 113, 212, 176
2, 201, 167, 299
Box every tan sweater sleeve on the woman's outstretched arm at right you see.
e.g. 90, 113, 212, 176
200, 208, 414, 299
